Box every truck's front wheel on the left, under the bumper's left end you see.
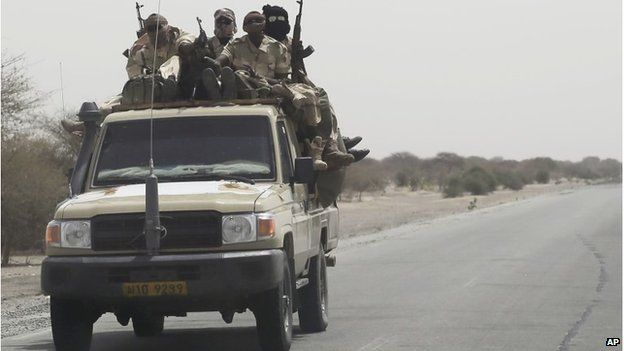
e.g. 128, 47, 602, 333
50, 297, 94, 351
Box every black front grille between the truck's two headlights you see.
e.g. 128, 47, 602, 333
91, 211, 221, 251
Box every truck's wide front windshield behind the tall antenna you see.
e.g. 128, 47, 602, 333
93, 116, 275, 186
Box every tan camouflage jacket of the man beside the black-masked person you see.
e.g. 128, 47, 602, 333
221, 35, 290, 78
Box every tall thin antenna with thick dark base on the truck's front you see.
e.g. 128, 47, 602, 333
144, 0, 164, 255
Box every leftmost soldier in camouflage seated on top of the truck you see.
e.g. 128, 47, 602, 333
126, 13, 195, 79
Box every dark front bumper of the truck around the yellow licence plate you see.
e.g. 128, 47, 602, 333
41, 250, 284, 300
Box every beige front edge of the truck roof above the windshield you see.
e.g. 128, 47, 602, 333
104, 99, 280, 123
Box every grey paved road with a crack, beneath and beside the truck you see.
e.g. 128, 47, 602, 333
2, 186, 622, 351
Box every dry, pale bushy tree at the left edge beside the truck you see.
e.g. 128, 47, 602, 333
0, 56, 72, 266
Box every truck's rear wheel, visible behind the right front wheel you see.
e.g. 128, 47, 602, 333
299, 246, 328, 333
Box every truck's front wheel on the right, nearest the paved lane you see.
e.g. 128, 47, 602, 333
253, 260, 293, 351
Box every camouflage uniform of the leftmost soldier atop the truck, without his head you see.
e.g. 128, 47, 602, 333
126, 26, 195, 78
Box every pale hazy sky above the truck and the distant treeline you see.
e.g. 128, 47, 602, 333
1, 0, 622, 160
